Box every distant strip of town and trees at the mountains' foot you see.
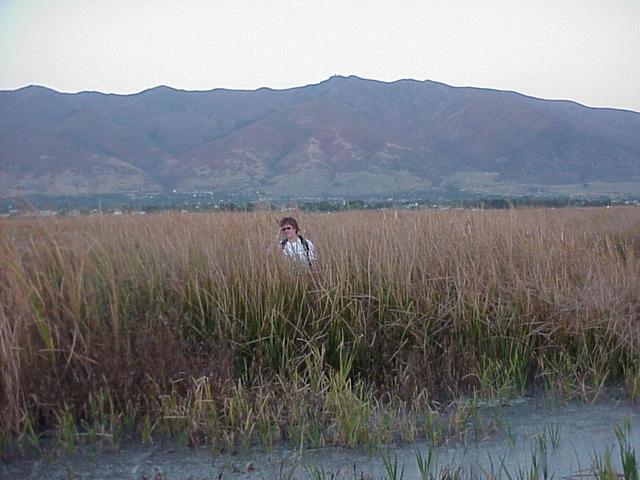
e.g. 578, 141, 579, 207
0, 191, 640, 217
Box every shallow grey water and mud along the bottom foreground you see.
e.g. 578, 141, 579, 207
5, 400, 640, 480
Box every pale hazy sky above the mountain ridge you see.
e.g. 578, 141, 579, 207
0, 0, 640, 111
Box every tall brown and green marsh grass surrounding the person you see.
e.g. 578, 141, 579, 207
0, 207, 640, 462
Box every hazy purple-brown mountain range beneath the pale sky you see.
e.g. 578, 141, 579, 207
0, 76, 640, 196
